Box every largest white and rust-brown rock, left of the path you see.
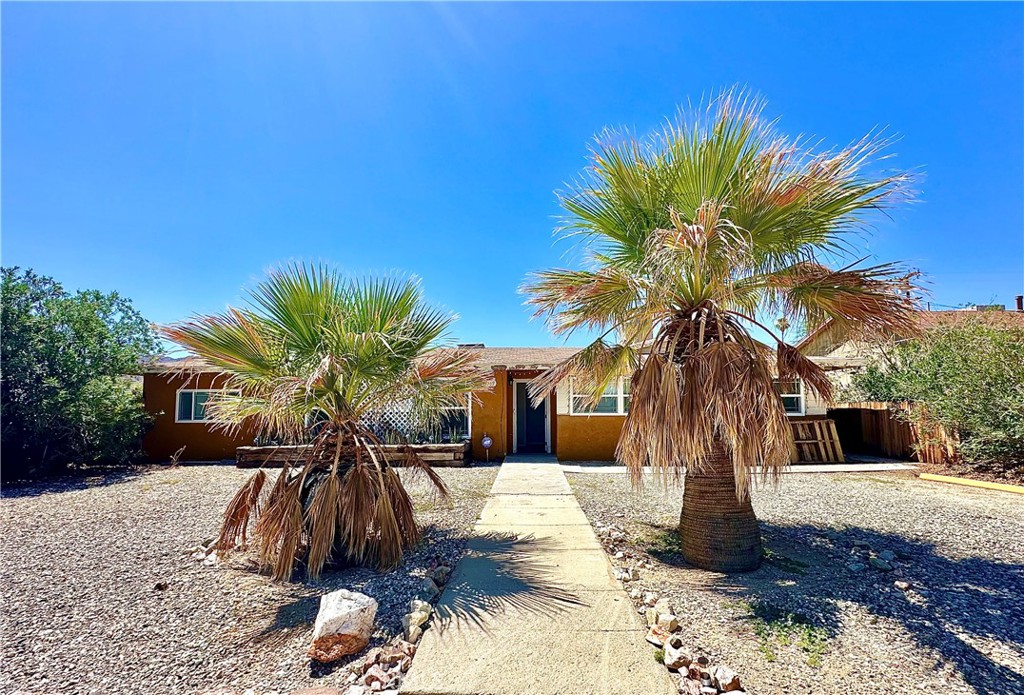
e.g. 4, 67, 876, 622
308, 589, 377, 663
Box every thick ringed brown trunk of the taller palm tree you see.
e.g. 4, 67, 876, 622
679, 442, 763, 572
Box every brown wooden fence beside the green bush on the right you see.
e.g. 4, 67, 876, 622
829, 400, 959, 464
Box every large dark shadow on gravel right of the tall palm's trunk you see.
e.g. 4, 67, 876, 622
648, 522, 1024, 693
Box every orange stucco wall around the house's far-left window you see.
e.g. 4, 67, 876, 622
142, 374, 253, 462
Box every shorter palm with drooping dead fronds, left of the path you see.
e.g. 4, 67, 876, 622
162, 265, 492, 579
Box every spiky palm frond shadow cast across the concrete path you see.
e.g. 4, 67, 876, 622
436, 533, 586, 629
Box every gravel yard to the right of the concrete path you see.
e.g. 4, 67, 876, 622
567, 472, 1024, 695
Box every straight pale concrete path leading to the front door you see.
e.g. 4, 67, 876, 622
401, 458, 676, 695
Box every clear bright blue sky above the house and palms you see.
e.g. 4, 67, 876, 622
0, 3, 1024, 345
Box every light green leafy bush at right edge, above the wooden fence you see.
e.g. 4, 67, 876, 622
848, 321, 1024, 466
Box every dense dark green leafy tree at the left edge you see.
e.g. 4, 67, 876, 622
0, 267, 158, 480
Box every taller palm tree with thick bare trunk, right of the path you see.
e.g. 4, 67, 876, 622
524, 91, 912, 571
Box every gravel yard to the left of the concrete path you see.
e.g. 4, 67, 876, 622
0, 466, 498, 693
